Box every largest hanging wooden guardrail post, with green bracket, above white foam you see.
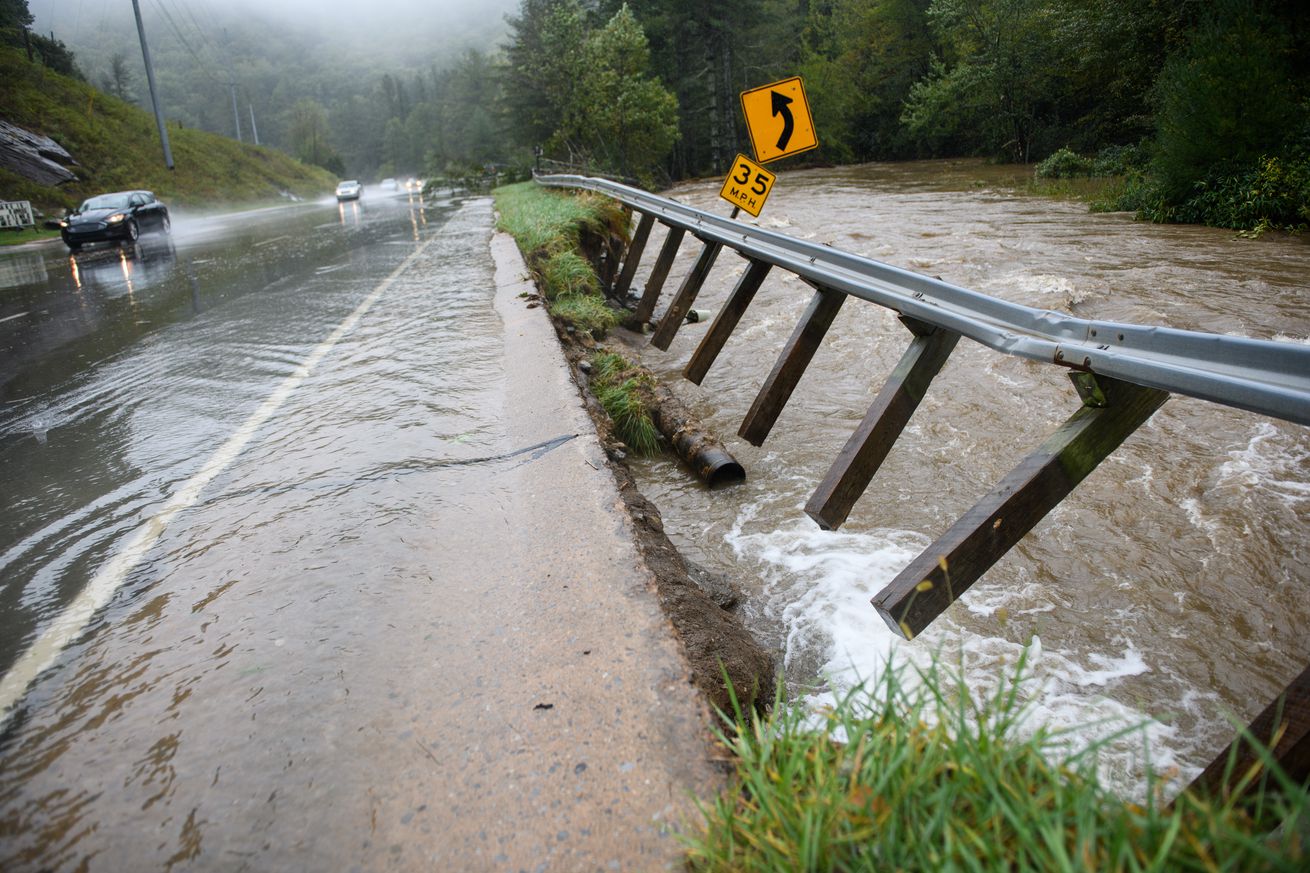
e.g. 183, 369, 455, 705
872, 372, 1169, 640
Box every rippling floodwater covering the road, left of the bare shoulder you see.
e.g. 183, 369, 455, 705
0, 188, 531, 870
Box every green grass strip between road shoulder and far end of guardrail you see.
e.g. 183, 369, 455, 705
494, 182, 626, 336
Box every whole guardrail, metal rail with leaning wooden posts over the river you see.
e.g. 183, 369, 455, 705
537, 167, 1310, 777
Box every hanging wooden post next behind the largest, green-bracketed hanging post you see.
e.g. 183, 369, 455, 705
806, 316, 960, 531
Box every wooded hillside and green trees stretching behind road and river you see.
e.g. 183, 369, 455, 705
10, 0, 1310, 228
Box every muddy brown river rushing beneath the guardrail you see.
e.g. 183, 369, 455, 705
623, 161, 1310, 793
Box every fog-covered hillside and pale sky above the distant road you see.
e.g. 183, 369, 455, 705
20, 0, 519, 177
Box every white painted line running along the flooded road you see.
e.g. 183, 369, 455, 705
0, 236, 436, 728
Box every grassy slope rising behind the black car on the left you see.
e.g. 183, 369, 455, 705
0, 47, 337, 228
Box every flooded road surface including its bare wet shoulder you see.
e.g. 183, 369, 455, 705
0, 188, 711, 872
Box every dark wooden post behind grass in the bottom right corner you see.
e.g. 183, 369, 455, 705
1188, 667, 1310, 798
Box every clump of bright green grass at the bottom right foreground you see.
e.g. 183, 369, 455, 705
686, 655, 1310, 872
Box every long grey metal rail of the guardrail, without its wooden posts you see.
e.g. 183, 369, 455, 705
537, 176, 1310, 425
